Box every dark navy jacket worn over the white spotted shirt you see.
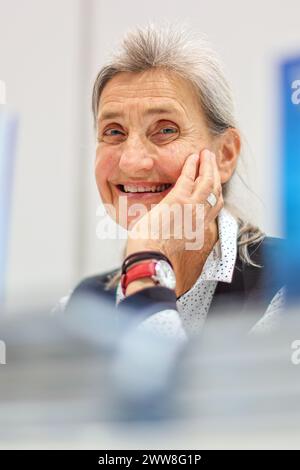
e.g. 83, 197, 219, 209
66, 237, 284, 328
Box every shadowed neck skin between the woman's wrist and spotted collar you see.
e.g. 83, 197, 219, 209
171, 220, 218, 298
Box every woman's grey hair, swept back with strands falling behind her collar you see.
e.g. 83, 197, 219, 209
92, 23, 265, 282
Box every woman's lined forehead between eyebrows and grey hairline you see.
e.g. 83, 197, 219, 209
98, 69, 200, 116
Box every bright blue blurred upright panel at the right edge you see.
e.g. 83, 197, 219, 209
280, 56, 300, 303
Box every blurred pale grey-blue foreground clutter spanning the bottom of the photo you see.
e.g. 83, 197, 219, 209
0, 297, 300, 449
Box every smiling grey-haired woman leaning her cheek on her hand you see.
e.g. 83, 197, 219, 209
61, 25, 283, 335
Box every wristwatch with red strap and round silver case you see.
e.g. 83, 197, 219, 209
121, 260, 176, 295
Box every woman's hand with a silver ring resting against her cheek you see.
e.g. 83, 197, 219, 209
126, 149, 223, 259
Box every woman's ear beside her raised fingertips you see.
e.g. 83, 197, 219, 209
216, 127, 241, 184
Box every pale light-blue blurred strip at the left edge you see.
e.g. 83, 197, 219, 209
0, 110, 17, 308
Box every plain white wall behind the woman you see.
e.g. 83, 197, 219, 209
0, 0, 300, 305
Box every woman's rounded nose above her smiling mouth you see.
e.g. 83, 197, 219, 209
119, 136, 154, 176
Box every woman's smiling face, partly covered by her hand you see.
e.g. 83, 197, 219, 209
95, 69, 213, 228
